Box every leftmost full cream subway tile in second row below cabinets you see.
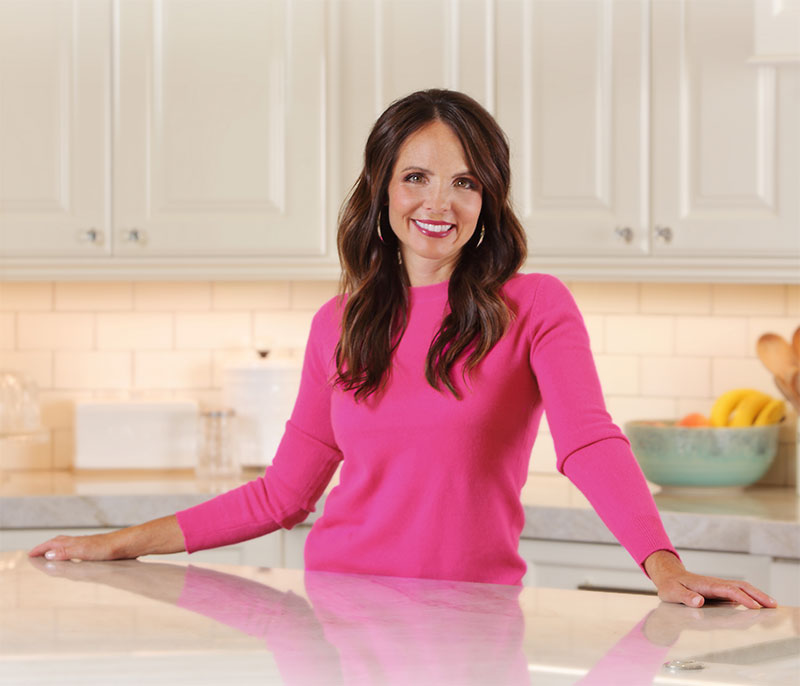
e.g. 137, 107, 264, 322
17, 312, 95, 350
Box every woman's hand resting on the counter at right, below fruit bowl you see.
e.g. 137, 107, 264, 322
644, 550, 778, 609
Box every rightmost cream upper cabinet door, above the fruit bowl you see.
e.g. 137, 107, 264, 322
652, 0, 800, 257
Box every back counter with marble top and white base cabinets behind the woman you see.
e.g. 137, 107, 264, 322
0, 471, 800, 605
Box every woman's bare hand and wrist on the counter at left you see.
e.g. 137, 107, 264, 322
28, 515, 185, 560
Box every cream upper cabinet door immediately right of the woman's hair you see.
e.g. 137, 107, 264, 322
497, 0, 648, 261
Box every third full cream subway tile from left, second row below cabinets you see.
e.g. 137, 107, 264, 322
175, 312, 253, 350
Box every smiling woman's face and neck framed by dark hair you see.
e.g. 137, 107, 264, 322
388, 121, 483, 286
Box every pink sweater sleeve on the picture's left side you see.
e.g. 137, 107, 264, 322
176, 301, 342, 553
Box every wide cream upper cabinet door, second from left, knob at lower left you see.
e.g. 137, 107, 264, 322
114, 0, 326, 256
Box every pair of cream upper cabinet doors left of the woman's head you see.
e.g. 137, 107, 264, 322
0, 0, 330, 267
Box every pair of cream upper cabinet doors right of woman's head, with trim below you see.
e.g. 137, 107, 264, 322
497, 0, 800, 281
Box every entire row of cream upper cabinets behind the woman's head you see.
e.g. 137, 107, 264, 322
0, 0, 800, 283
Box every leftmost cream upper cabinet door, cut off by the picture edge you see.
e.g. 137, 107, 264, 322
0, 0, 110, 258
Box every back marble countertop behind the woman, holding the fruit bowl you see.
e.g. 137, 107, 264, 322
0, 471, 800, 559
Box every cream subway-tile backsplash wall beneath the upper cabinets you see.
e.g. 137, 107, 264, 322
0, 281, 800, 485
